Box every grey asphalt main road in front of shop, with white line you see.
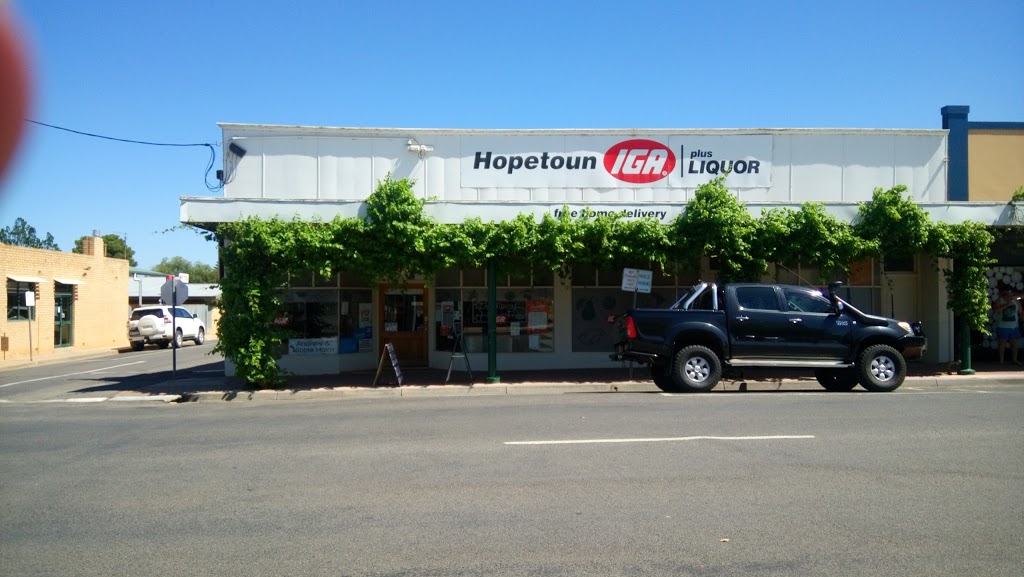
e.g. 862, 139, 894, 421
0, 377, 1024, 577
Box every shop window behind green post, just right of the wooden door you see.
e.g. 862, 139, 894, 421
434, 269, 555, 353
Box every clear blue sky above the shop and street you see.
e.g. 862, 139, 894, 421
0, 0, 1024, 267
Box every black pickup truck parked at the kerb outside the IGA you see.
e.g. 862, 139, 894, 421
611, 283, 928, 393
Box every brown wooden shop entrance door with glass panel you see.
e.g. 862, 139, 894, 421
378, 285, 428, 367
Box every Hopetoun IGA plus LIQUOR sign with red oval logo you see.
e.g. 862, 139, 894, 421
461, 134, 772, 189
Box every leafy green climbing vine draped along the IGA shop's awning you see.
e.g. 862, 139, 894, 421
216, 176, 993, 387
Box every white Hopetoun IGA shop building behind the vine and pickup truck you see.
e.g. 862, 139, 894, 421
181, 124, 1006, 374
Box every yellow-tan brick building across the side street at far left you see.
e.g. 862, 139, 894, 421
0, 237, 129, 362
